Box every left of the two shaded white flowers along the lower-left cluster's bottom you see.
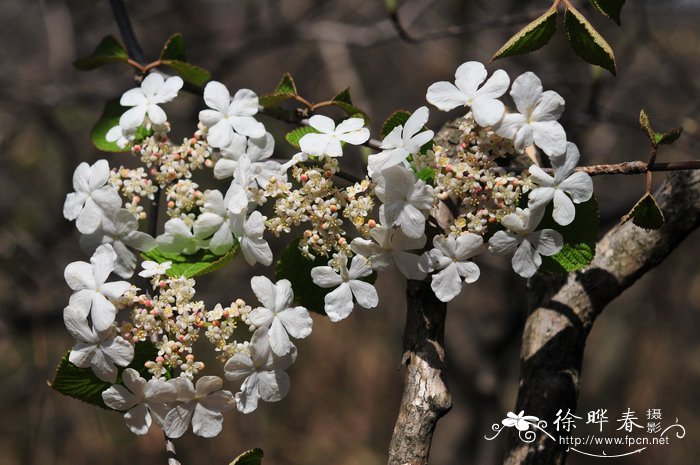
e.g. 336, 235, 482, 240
102, 368, 177, 434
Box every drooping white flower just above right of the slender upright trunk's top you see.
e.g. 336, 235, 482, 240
419, 233, 484, 302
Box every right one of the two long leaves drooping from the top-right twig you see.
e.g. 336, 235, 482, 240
564, 6, 617, 75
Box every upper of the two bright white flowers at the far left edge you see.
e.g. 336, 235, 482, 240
63, 160, 122, 234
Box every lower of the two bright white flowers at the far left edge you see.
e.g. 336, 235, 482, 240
64, 244, 131, 331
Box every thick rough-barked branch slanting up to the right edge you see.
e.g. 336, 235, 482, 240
504, 171, 700, 465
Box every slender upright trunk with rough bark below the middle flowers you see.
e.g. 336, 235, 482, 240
388, 280, 452, 465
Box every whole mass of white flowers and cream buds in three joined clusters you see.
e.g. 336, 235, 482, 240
64, 62, 593, 437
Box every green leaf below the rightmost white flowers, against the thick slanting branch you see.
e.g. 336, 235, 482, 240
538, 196, 600, 274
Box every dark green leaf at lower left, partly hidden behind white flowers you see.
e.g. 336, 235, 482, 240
49, 341, 158, 409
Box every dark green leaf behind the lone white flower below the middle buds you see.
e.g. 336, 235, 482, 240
275, 239, 377, 315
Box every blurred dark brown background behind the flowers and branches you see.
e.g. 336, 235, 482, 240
0, 0, 700, 465
